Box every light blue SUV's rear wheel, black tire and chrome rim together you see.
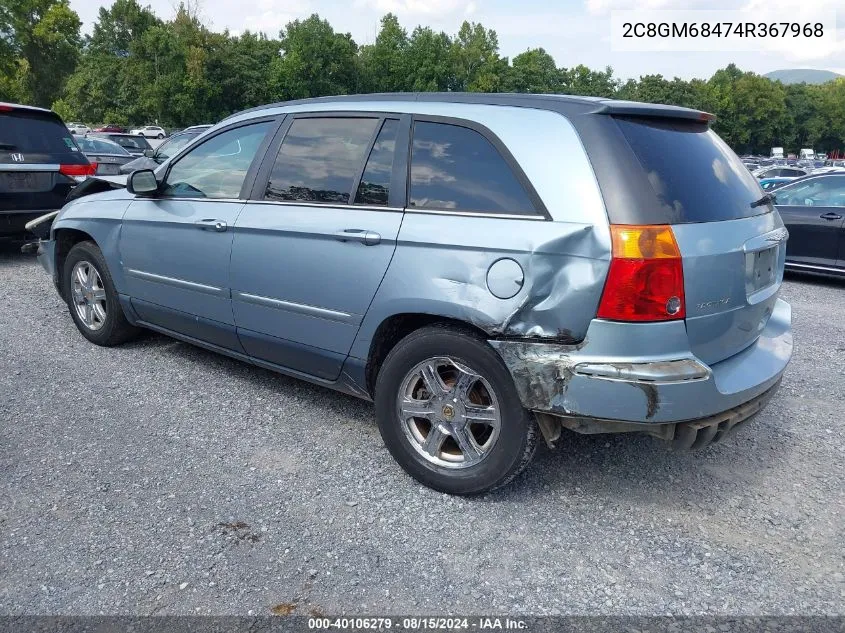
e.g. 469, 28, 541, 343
375, 326, 537, 495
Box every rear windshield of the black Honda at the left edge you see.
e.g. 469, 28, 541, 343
0, 111, 79, 156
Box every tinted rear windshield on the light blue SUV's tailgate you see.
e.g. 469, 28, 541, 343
616, 117, 770, 224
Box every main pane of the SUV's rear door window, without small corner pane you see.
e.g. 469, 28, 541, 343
264, 117, 379, 204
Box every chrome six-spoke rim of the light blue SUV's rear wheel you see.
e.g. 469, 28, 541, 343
396, 357, 501, 468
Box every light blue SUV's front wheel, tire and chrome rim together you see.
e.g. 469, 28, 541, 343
62, 242, 139, 346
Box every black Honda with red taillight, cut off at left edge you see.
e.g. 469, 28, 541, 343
0, 102, 94, 238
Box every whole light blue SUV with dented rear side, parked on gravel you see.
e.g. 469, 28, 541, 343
34, 93, 792, 494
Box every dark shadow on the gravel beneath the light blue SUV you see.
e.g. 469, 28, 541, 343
121, 334, 790, 506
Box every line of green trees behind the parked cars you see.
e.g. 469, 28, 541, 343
0, 0, 845, 154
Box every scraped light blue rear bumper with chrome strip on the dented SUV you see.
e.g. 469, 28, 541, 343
490, 299, 792, 430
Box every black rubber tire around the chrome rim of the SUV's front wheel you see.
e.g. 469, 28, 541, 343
62, 242, 140, 347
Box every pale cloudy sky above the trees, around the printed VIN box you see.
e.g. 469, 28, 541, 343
70, 0, 845, 79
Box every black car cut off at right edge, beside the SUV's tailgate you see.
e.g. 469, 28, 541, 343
772, 173, 845, 275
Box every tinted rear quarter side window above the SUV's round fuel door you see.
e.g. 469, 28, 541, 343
408, 121, 537, 215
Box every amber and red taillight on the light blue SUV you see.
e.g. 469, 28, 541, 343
598, 225, 686, 321
